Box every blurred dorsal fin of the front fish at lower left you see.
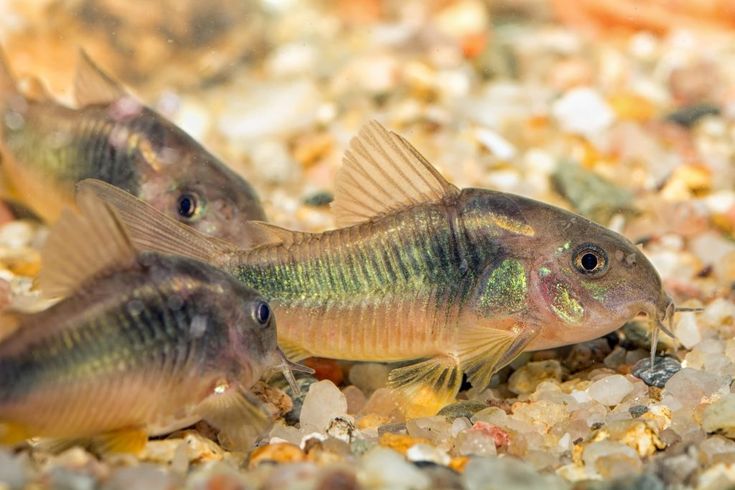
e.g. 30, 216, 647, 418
39, 186, 136, 297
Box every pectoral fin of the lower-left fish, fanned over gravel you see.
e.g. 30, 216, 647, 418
199, 385, 272, 451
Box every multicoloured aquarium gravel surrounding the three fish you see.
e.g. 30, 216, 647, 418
0, 0, 735, 490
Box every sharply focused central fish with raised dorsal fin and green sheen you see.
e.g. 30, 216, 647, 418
85, 121, 675, 416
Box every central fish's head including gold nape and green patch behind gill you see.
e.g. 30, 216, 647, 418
459, 189, 674, 349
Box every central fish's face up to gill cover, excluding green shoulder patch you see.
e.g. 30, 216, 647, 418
524, 197, 674, 348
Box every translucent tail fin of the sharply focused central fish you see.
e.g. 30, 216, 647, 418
77, 179, 262, 265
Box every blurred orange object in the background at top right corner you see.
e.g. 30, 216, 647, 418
551, 0, 735, 34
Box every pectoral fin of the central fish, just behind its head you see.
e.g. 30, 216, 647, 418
460, 324, 539, 389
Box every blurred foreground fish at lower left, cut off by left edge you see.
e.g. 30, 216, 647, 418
0, 187, 299, 453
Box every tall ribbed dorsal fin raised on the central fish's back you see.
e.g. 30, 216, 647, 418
332, 121, 459, 226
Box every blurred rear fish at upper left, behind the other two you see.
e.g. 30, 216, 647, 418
0, 47, 266, 247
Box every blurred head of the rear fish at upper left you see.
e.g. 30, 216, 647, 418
139, 113, 265, 245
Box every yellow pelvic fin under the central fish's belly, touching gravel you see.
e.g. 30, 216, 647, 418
388, 356, 462, 418
